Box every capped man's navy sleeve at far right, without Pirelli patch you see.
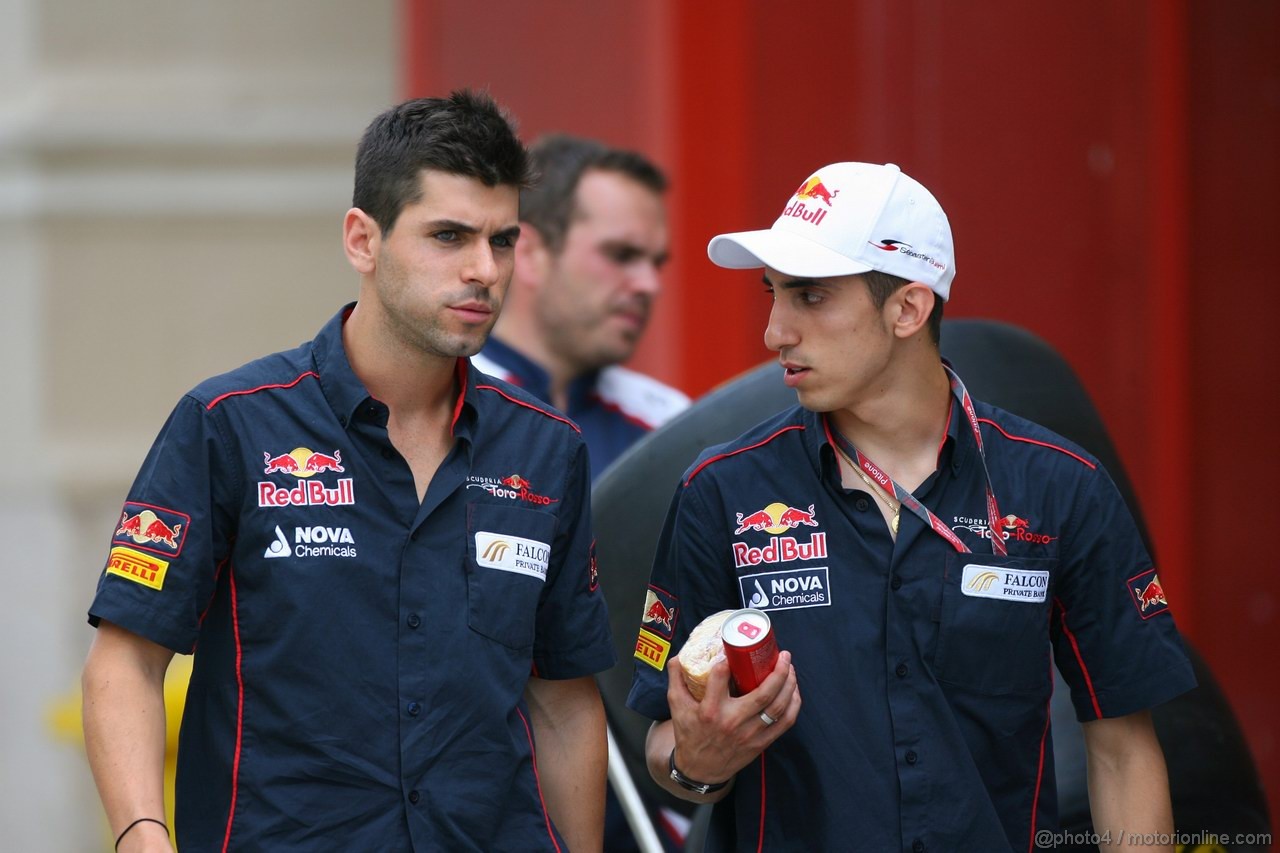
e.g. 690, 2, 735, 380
1052, 467, 1196, 721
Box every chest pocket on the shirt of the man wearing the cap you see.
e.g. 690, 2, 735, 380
933, 553, 1057, 694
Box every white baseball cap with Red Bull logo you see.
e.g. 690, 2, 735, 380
707, 163, 956, 300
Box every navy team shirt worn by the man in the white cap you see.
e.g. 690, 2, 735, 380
628, 391, 1194, 853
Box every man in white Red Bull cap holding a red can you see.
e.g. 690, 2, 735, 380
628, 163, 1196, 853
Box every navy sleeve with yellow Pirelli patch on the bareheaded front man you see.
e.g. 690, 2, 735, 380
88, 397, 238, 653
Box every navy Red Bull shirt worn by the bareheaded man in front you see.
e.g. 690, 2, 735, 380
90, 306, 614, 853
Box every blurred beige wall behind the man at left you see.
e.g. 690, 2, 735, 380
0, 0, 399, 850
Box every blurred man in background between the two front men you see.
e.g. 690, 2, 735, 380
475, 134, 689, 475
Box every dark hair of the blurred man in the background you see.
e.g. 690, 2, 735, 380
520, 133, 667, 252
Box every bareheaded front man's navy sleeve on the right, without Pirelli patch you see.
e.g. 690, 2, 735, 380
534, 442, 616, 679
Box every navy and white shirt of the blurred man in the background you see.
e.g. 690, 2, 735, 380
474, 337, 689, 475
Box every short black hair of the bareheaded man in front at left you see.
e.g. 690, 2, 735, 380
352, 90, 532, 234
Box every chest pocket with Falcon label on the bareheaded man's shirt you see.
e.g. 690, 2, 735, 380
466, 503, 557, 649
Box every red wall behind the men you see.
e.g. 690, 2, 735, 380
401, 0, 1280, 815
